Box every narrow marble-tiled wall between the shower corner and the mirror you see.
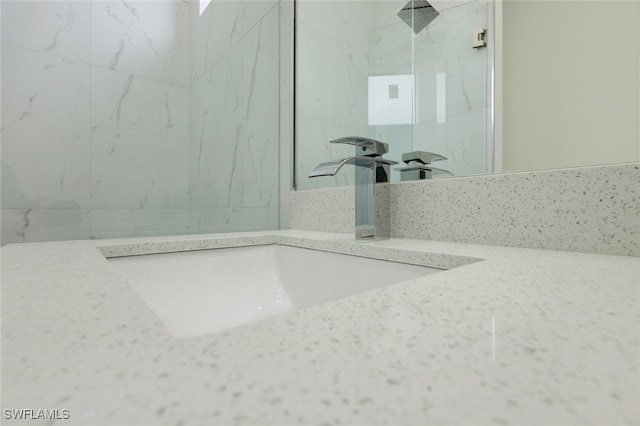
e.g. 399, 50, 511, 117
189, 0, 280, 232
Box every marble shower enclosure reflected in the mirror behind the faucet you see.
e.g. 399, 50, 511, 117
295, 0, 493, 189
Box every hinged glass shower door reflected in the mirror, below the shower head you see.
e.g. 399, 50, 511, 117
368, 0, 492, 181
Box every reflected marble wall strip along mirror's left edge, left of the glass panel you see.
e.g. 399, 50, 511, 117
295, 1, 376, 189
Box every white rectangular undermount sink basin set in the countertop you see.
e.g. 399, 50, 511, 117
109, 245, 441, 337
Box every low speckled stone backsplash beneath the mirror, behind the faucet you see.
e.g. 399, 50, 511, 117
290, 163, 640, 256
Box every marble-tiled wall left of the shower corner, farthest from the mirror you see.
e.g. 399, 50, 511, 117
1, 1, 191, 244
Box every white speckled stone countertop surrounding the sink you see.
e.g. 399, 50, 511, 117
1, 231, 640, 425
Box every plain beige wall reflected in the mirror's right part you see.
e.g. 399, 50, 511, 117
503, 0, 640, 171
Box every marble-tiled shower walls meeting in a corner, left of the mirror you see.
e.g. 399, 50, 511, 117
0, 0, 280, 244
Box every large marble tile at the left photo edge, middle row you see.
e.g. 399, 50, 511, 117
2, 43, 91, 213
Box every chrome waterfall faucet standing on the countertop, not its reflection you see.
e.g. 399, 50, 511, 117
309, 136, 398, 239
